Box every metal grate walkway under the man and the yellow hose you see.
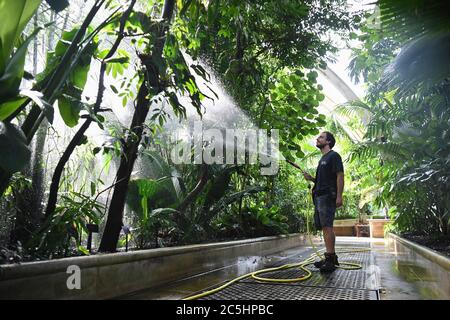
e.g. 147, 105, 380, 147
193, 251, 379, 300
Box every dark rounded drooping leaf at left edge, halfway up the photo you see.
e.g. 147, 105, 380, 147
0, 121, 31, 173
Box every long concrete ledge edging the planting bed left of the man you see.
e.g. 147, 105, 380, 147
0, 234, 306, 299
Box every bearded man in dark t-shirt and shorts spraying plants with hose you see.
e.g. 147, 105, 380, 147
303, 131, 344, 272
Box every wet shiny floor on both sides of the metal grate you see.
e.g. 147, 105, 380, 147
120, 237, 450, 300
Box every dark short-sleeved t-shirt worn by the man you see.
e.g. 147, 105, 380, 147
314, 150, 344, 195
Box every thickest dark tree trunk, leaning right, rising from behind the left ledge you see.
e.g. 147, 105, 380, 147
99, 0, 175, 252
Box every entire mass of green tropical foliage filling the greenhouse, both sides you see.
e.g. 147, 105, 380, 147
0, 0, 450, 260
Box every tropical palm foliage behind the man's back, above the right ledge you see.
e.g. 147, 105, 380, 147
338, 1, 450, 235
